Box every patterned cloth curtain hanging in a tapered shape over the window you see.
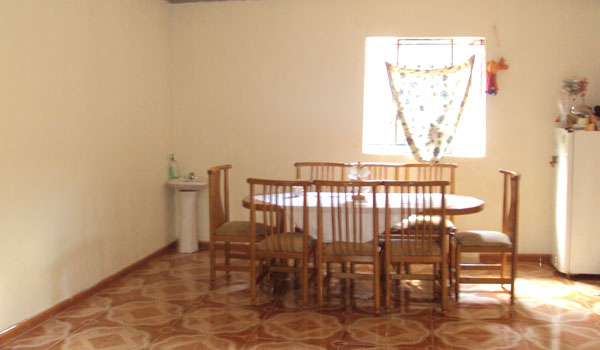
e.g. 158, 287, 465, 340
386, 56, 475, 163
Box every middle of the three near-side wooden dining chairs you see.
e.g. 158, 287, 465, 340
315, 180, 381, 314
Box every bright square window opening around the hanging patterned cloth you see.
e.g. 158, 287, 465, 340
363, 37, 485, 157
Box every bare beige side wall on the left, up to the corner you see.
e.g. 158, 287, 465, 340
0, 0, 174, 330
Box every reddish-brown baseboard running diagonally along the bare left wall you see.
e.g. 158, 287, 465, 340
0, 242, 177, 347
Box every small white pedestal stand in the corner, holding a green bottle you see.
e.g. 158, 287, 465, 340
166, 177, 208, 253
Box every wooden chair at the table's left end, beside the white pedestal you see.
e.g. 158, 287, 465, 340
208, 165, 264, 286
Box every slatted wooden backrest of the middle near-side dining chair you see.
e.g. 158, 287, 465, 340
314, 180, 381, 256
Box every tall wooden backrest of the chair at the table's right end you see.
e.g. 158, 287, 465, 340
500, 169, 521, 246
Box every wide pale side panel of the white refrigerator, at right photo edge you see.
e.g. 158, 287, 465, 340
569, 131, 600, 274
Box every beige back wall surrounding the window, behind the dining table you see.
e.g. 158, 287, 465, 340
172, 0, 600, 253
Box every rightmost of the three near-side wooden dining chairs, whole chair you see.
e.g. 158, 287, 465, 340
383, 181, 449, 312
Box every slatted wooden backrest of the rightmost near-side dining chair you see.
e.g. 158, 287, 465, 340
383, 181, 449, 257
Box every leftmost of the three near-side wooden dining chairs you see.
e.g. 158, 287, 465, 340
248, 179, 316, 307
